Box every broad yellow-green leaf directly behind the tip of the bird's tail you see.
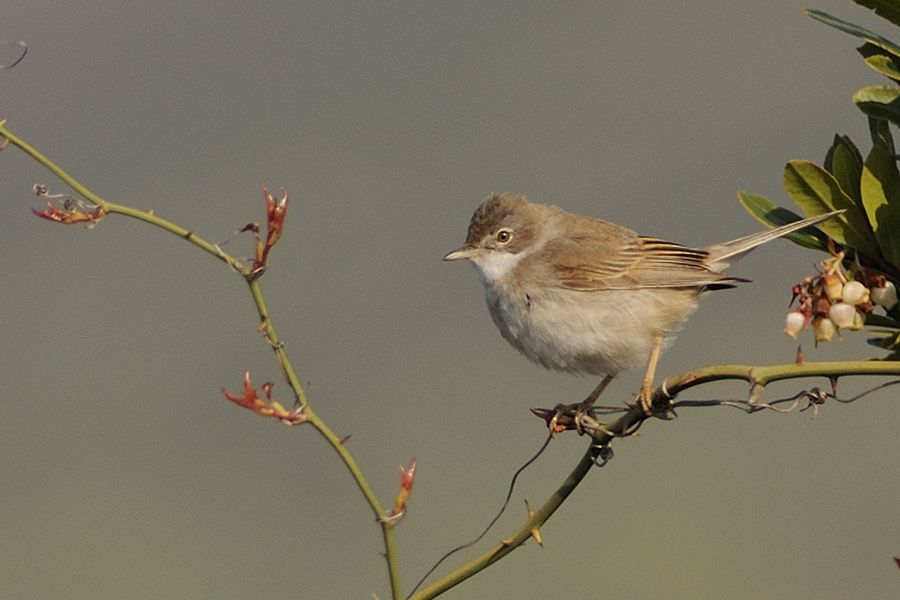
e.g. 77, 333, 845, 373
784, 160, 878, 256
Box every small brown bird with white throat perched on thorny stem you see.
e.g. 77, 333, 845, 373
444, 193, 842, 415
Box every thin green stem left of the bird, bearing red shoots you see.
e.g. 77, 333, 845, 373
0, 120, 402, 600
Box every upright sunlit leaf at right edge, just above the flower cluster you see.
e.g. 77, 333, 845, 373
860, 144, 900, 265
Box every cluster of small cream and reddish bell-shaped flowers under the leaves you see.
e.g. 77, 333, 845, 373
784, 254, 897, 343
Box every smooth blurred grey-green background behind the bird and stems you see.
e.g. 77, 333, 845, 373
0, 0, 900, 600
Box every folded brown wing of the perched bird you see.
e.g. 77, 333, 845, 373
545, 228, 742, 292
